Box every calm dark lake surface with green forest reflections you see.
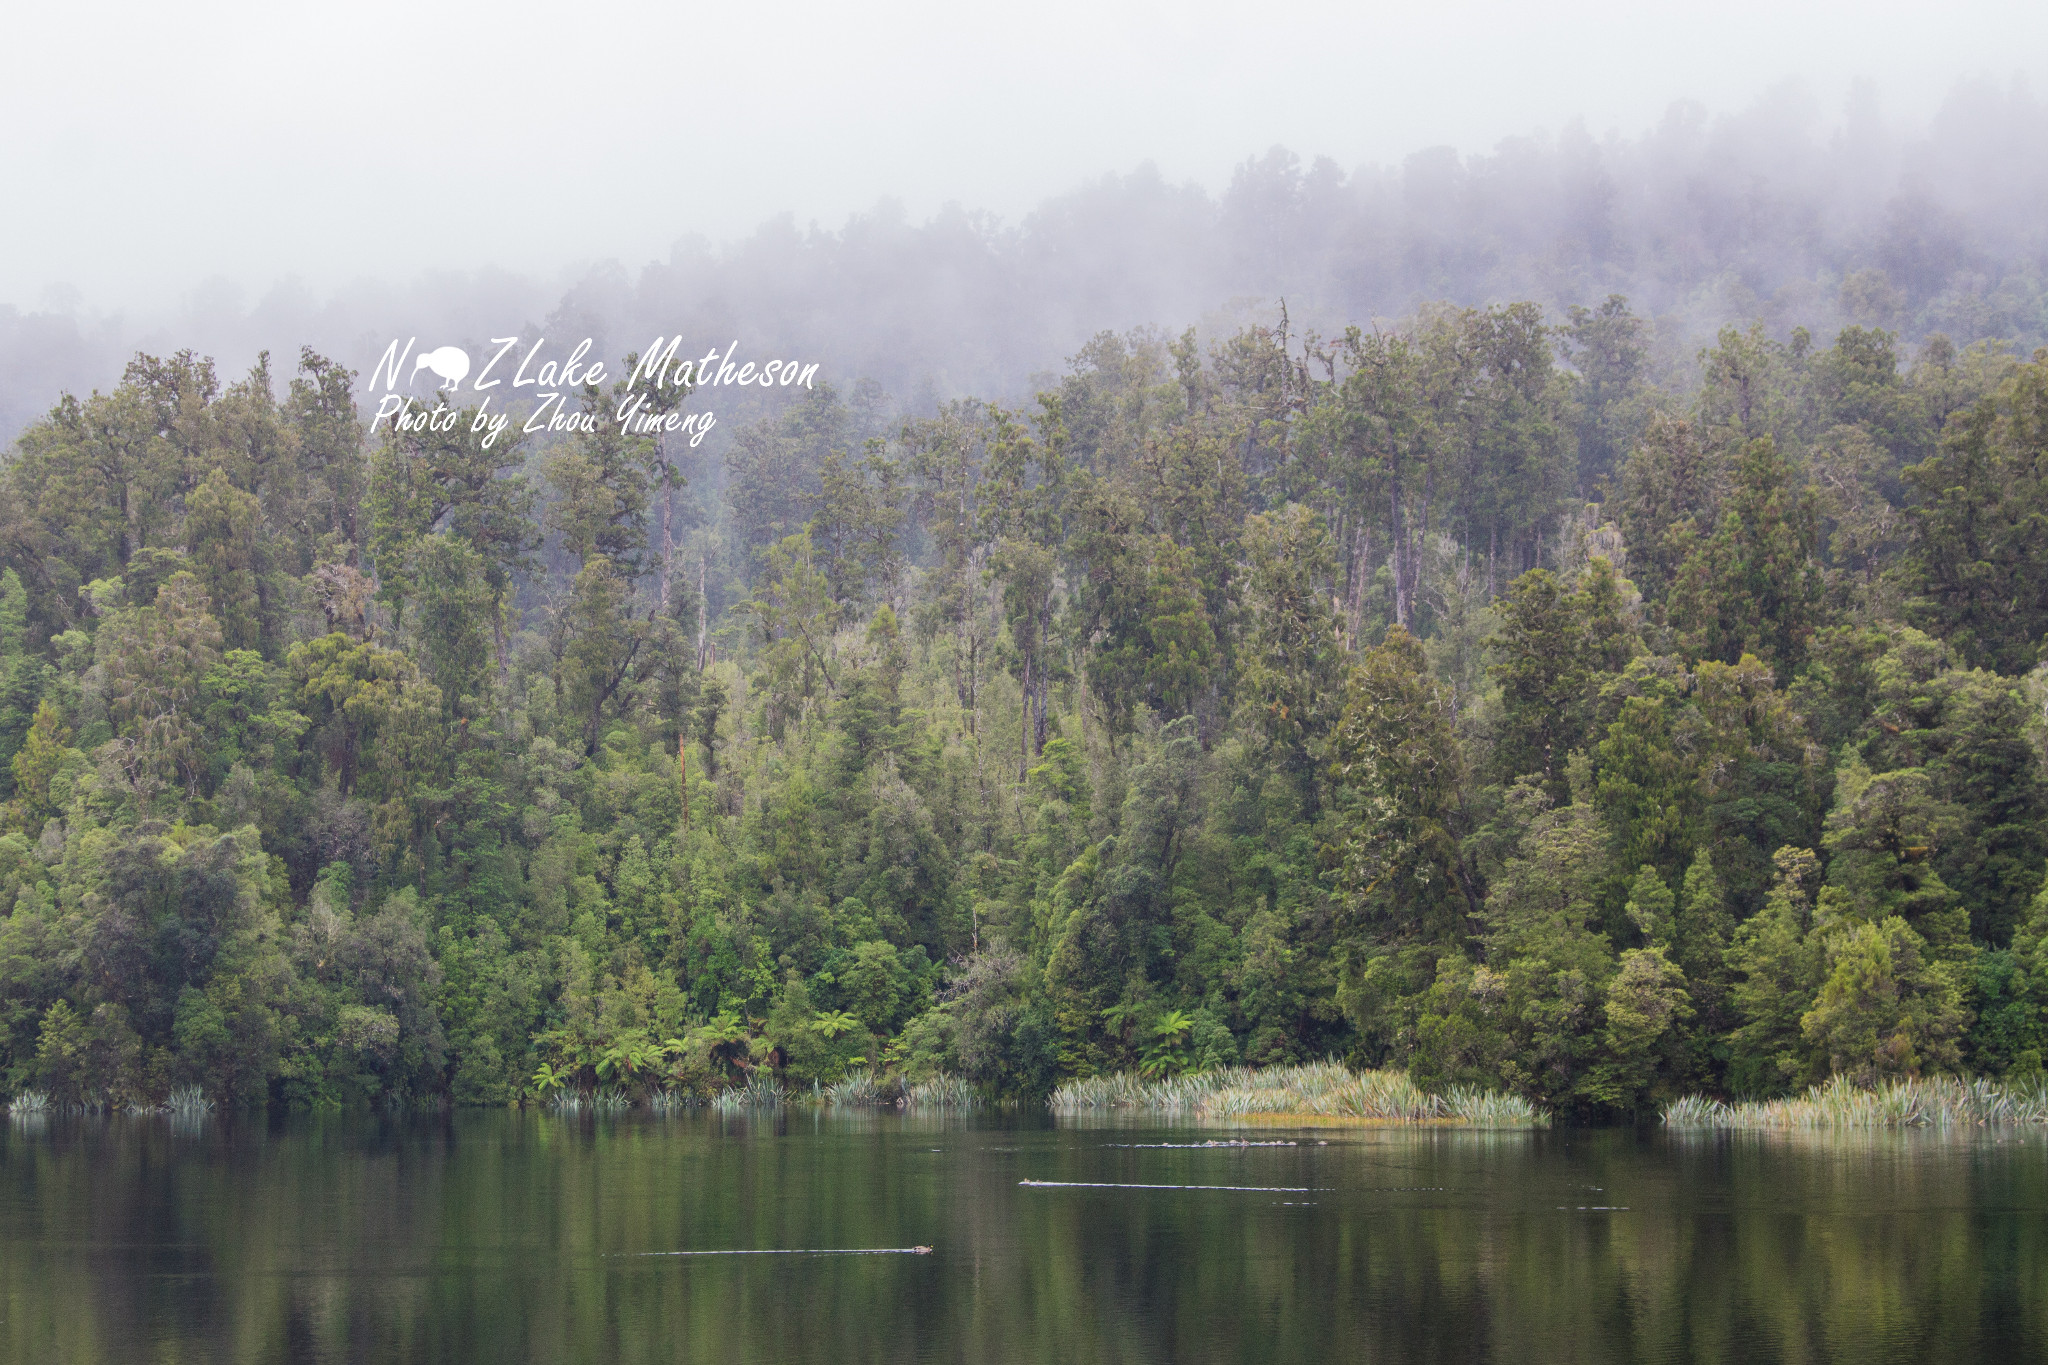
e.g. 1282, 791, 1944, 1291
0, 1109, 2048, 1365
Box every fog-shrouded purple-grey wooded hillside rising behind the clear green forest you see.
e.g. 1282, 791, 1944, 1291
0, 80, 2048, 446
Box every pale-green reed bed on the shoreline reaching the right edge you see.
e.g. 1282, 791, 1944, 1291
1663, 1076, 2048, 1130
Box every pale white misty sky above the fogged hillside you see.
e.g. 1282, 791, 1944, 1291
12, 0, 2048, 311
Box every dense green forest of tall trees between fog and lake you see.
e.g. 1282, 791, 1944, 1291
0, 297, 2048, 1117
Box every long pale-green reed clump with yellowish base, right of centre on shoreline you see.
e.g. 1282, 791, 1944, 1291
1053, 1062, 1548, 1128
